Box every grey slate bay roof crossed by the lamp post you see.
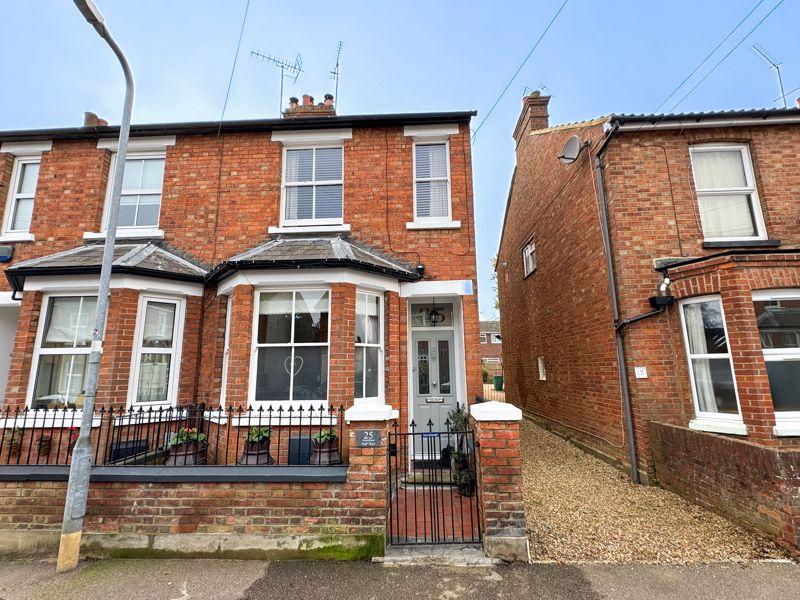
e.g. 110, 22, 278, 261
6, 242, 208, 290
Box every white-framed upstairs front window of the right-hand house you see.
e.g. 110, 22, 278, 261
690, 144, 766, 241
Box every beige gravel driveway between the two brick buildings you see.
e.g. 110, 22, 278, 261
522, 420, 785, 563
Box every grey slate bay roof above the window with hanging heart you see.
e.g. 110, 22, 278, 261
208, 235, 420, 282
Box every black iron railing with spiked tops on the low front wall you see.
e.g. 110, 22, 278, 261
0, 403, 347, 467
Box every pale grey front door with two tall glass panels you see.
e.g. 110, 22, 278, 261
412, 330, 456, 433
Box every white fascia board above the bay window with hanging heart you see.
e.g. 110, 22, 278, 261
217, 269, 400, 296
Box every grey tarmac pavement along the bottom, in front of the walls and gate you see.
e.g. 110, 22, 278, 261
0, 560, 800, 600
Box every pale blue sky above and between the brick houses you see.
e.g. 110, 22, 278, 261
0, 0, 800, 317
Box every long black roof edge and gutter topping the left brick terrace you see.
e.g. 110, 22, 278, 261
0, 110, 478, 142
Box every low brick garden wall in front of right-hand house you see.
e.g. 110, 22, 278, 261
650, 423, 800, 553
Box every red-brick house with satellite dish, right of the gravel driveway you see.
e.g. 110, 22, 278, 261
497, 92, 800, 551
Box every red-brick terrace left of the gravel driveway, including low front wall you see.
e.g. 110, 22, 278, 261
0, 96, 524, 556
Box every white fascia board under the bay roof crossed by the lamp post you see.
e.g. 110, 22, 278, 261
23, 275, 203, 296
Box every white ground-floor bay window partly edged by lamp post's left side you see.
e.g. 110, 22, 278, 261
31, 296, 97, 408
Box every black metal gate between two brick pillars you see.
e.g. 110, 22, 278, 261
387, 421, 481, 545
